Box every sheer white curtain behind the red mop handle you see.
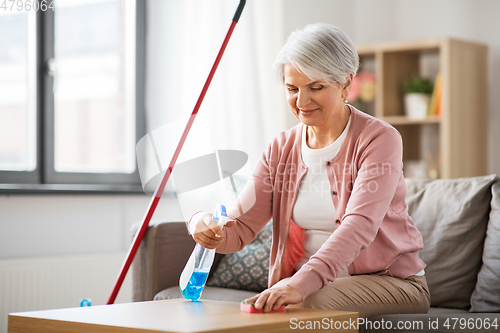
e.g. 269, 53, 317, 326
143, 0, 289, 220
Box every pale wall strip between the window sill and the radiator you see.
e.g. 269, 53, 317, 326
0, 194, 182, 256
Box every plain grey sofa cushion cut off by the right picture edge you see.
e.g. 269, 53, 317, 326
470, 182, 500, 312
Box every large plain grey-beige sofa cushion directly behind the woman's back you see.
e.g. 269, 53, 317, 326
406, 175, 496, 309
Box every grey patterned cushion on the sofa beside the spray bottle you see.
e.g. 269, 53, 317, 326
207, 220, 273, 292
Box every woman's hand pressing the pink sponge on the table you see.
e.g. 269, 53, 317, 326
245, 286, 302, 312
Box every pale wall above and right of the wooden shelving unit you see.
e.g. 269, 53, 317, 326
283, 0, 500, 175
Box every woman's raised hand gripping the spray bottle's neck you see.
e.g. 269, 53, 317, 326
189, 212, 236, 249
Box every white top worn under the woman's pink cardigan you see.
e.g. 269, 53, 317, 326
292, 117, 351, 276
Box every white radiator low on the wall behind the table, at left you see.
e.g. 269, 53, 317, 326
0, 252, 132, 333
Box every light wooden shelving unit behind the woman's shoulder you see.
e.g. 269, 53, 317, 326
357, 38, 488, 178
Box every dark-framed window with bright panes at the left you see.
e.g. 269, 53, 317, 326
0, 0, 145, 188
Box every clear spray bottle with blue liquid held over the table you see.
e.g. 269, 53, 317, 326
179, 204, 228, 301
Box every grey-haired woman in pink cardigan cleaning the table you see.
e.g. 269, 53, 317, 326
189, 23, 430, 317
